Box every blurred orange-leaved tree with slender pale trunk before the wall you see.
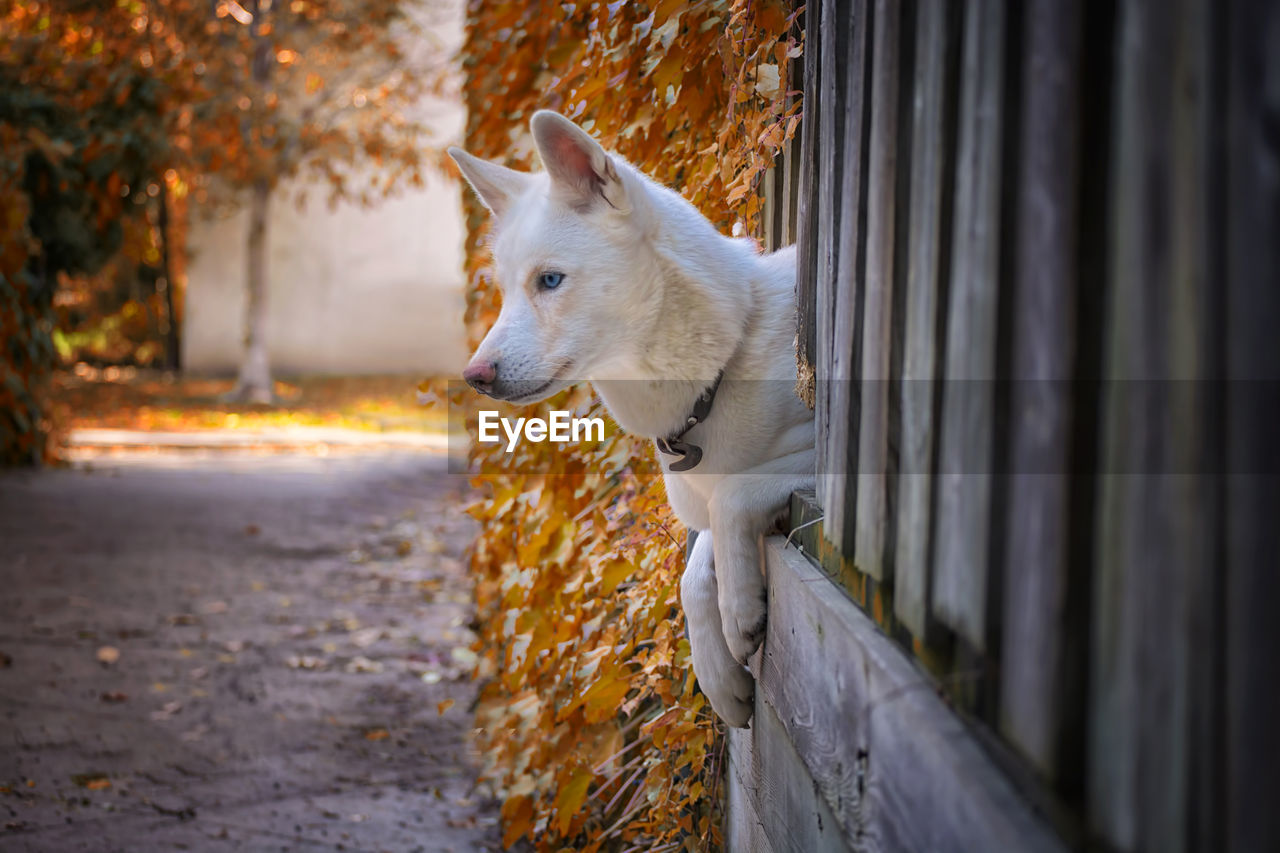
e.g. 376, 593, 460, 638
184, 0, 447, 402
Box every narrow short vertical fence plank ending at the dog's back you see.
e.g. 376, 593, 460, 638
795, 4, 822, 409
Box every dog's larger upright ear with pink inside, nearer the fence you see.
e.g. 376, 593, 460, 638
530, 110, 627, 210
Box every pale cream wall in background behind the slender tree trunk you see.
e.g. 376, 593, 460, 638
182, 4, 466, 374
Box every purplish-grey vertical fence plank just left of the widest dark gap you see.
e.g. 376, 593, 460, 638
1000, 0, 1083, 779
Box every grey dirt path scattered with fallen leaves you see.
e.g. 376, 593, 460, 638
0, 451, 498, 852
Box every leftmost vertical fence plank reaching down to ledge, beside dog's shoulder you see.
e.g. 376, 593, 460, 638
818, 0, 874, 553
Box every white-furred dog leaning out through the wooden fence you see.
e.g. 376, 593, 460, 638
449, 110, 814, 726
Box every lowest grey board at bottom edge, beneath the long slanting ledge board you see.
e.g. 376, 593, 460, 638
724, 695, 851, 853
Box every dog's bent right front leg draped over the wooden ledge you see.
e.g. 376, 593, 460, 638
710, 451, 814, 663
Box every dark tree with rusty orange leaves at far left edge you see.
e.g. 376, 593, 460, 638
0, 0, 197, 462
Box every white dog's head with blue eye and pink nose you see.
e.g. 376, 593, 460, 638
449, 110, 658, 403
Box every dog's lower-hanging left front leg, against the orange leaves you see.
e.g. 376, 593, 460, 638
680, 530, 755, 727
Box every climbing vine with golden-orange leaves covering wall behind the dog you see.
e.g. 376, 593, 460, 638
463, 0, 800, 850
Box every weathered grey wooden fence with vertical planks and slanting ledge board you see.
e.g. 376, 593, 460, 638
728, 0, 1280, 853
